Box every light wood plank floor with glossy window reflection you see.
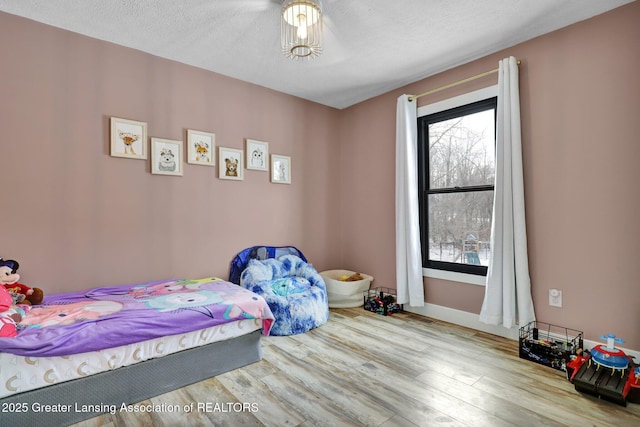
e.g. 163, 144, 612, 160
76, 308, 640, 427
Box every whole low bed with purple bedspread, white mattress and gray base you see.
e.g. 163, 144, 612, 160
0, 278, 274, 426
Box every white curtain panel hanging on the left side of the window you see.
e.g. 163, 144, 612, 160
396, 95, 424, 307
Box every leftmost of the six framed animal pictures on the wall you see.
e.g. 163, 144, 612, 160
111, 117, 147, 159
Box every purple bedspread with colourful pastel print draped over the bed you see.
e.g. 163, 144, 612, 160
0, 278, 274, 357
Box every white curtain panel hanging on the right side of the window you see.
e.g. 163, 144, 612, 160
480, 57, 535, 328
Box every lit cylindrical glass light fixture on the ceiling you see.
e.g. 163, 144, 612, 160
280, 0, 322, 59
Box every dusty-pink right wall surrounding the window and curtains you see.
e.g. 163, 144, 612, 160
340, 2, 640, 349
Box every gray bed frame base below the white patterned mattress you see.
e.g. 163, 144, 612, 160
0, 330, 262, 427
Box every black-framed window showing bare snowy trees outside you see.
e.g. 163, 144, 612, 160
418, 96, 497, 275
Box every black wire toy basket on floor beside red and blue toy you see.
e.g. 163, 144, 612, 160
519, 321, 583, 371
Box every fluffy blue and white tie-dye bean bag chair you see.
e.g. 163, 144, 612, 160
240, 255, 329, 335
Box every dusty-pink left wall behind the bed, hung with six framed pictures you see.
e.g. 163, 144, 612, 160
0, 13, 340, 293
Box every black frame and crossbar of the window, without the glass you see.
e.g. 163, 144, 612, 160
418, 96, 498, 276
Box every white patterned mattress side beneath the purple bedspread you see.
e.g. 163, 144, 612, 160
0, 319, 263, 399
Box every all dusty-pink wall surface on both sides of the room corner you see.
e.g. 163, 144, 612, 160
0, 2, 640, 349
